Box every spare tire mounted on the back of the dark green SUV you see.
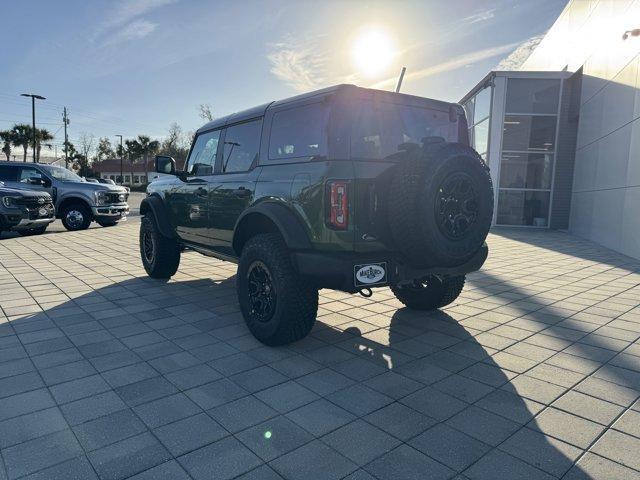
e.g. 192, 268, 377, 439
387, 142, 493, 267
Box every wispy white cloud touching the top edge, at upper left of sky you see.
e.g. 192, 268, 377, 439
91, 0, 177, 46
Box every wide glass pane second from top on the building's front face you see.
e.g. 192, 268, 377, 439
502, 115, 556, 152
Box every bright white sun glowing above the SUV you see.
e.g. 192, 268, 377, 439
351, 27, 395, 77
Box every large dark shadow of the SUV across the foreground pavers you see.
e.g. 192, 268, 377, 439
0, 276, 612, 480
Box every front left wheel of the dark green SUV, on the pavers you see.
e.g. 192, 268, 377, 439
139, 214, 180, 278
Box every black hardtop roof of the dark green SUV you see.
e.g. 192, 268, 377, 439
196, 84, 454, 133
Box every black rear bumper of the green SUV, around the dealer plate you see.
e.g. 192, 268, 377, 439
293, 243, 489, 293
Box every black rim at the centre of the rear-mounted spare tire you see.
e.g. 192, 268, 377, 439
435, 172, 480, 240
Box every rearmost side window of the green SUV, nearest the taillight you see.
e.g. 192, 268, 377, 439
269, 103, 327, 160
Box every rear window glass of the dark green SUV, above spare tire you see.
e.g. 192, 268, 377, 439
351, 100, 458, 159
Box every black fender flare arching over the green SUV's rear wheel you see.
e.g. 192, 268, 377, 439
232, 202, 312, 255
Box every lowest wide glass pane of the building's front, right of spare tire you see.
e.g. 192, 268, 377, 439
497, 190, 551, 227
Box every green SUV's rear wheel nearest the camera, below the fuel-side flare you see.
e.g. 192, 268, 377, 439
236, 233, 318, 346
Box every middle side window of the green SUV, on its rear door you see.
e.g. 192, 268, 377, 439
222, 120, 262, 173
